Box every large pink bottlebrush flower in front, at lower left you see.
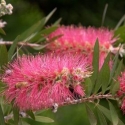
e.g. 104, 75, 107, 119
3, 53, 92, 110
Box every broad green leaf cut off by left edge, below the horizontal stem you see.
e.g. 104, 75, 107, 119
0, 45, 8, 66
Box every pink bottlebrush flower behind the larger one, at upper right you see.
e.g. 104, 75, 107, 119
47, 26, 117, 67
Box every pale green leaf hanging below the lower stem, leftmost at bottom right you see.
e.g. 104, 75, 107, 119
86, 104, 97, 125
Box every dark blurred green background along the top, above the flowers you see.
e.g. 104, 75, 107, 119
3, 0, 125, 40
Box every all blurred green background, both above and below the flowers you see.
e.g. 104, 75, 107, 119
2, 0, 125, 125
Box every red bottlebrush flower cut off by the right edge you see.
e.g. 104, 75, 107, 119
117, 71, 125, 113
